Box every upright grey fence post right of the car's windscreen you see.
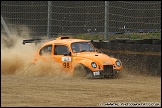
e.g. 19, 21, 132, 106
104, 1, 109, 41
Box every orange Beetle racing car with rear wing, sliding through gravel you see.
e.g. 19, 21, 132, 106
23, 37, 122, 78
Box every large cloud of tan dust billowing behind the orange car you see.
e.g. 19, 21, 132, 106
1, 29, 69, 76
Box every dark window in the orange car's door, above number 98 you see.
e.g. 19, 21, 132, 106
54, 45, 69, 55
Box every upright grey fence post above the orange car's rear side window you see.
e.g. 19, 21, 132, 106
47, 1, 52, 37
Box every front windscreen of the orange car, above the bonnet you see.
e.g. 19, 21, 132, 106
71, 42, 95, 53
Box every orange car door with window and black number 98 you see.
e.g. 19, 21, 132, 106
52, 44, 72, 71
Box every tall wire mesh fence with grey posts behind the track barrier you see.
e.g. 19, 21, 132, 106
1, 1, 161, 36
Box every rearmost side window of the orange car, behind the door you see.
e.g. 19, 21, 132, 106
39, 45, 52, 55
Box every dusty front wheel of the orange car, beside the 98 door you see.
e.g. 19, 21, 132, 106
73, 64, 93, 79
